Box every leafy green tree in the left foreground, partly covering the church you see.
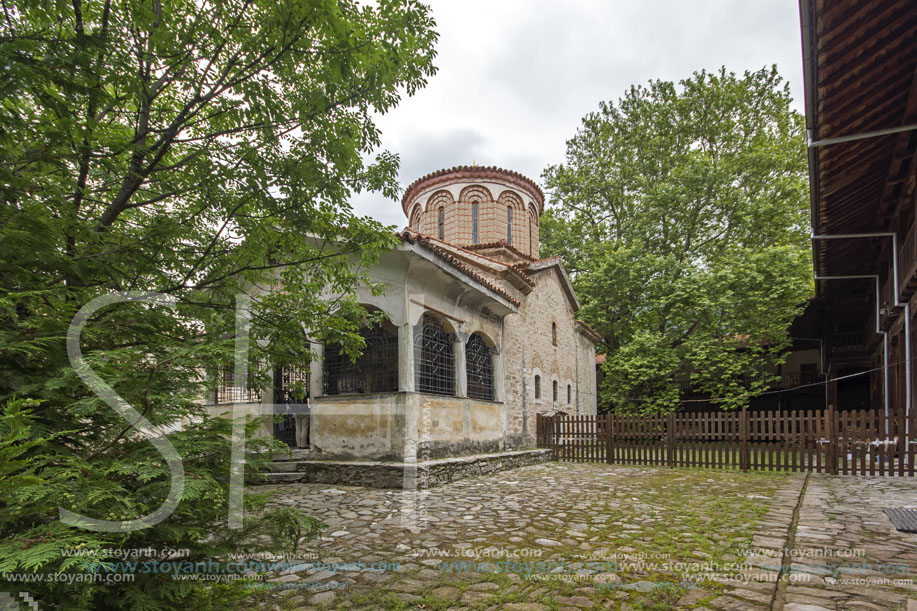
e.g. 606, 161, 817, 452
0, 0, 436, 609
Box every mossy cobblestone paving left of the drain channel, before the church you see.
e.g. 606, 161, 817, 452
246, 463, 804, 611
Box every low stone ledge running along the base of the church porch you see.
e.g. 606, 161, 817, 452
254, 450, 551, 490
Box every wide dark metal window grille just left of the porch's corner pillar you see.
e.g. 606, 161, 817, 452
323, 325, 398, 395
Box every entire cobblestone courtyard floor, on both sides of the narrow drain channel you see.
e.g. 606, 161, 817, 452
245, 463, 917, 611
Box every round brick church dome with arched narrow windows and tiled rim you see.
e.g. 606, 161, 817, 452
401, 166, 544, 259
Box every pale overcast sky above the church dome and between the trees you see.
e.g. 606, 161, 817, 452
353, 0, 803, 228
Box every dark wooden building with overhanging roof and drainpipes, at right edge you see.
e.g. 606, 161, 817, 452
800, 0, 917, 417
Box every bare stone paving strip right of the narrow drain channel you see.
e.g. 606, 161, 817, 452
784, 474, 917, 611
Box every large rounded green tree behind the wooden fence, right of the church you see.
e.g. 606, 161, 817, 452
542, 67, 812, 411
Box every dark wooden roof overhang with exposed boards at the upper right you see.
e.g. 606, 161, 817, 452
800, 0, 917, 295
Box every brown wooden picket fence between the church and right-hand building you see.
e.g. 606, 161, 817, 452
536, 409, 917, 476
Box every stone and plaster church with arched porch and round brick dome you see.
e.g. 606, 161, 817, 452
217, 166, 600, 478
